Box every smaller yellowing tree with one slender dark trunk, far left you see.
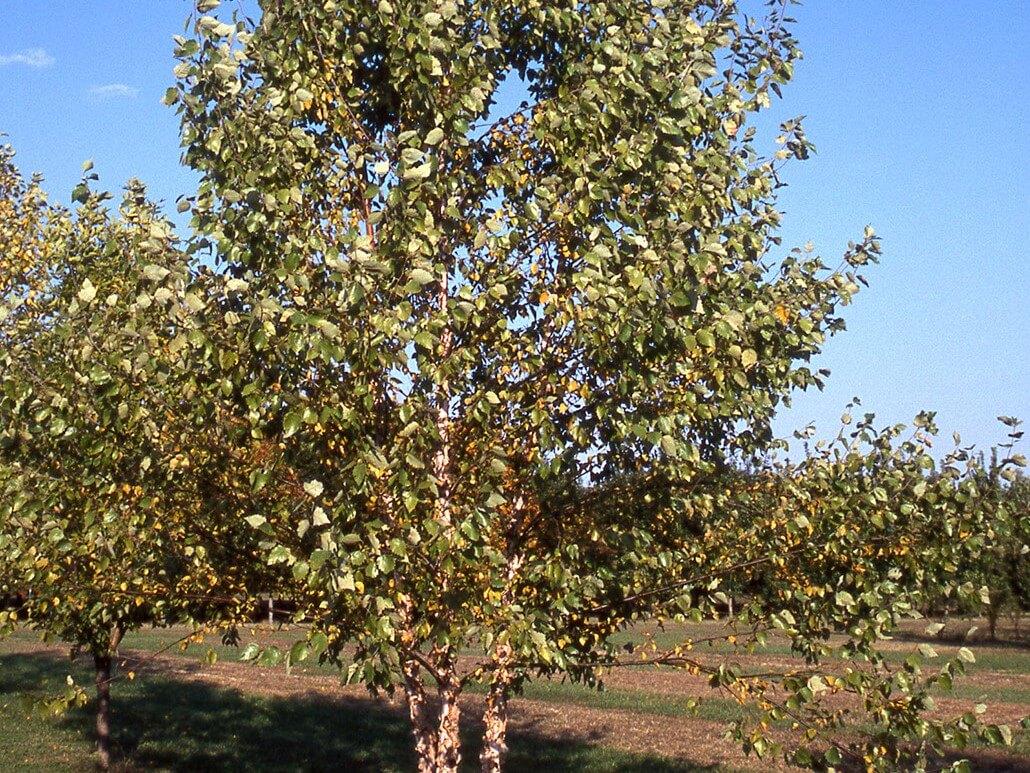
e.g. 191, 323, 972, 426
0, 148, 269, 768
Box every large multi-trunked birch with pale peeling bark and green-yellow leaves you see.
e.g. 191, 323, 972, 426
167, 0, 1013, 772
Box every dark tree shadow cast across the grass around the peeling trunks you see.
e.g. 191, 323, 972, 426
0, 654, 714, 773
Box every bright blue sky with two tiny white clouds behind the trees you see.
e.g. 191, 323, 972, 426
0, 0, 1030, 446
